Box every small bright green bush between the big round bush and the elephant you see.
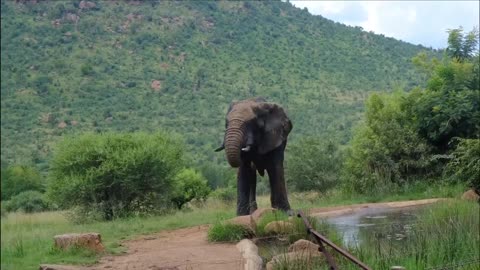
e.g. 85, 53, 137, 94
172, 169, 210, 209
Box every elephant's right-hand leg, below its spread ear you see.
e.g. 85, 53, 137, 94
267, 148, 290, 211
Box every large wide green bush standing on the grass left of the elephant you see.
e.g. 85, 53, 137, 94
48, 133, 183, 220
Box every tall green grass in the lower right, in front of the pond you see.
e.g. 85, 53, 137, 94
276, 200, 480, 270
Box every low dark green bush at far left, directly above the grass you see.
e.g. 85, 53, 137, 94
5, 190, 48, 213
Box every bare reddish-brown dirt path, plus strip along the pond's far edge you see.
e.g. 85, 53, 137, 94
50, 199, 445, 270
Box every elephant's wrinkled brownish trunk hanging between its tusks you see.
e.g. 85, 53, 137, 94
225, 119, 245, 168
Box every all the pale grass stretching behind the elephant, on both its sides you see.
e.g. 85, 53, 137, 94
1, 186, 463, 270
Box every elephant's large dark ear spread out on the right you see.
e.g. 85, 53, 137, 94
254, 102, 292, 154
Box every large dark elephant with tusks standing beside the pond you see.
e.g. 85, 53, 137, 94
215, 98, 293, 216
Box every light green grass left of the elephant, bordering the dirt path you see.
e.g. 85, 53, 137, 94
1, 201, 235, 270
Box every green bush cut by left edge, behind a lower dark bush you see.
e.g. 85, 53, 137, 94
1, 165, 43, 201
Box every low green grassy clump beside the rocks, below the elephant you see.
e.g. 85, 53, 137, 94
208, 223, 252, 242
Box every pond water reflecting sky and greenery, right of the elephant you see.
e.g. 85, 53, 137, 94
326, 207, 424, 246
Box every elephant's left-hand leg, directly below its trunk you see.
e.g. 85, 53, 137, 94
237, 164, 255, 216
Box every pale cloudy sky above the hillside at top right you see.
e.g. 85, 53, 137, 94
290, 1, 480, 49
